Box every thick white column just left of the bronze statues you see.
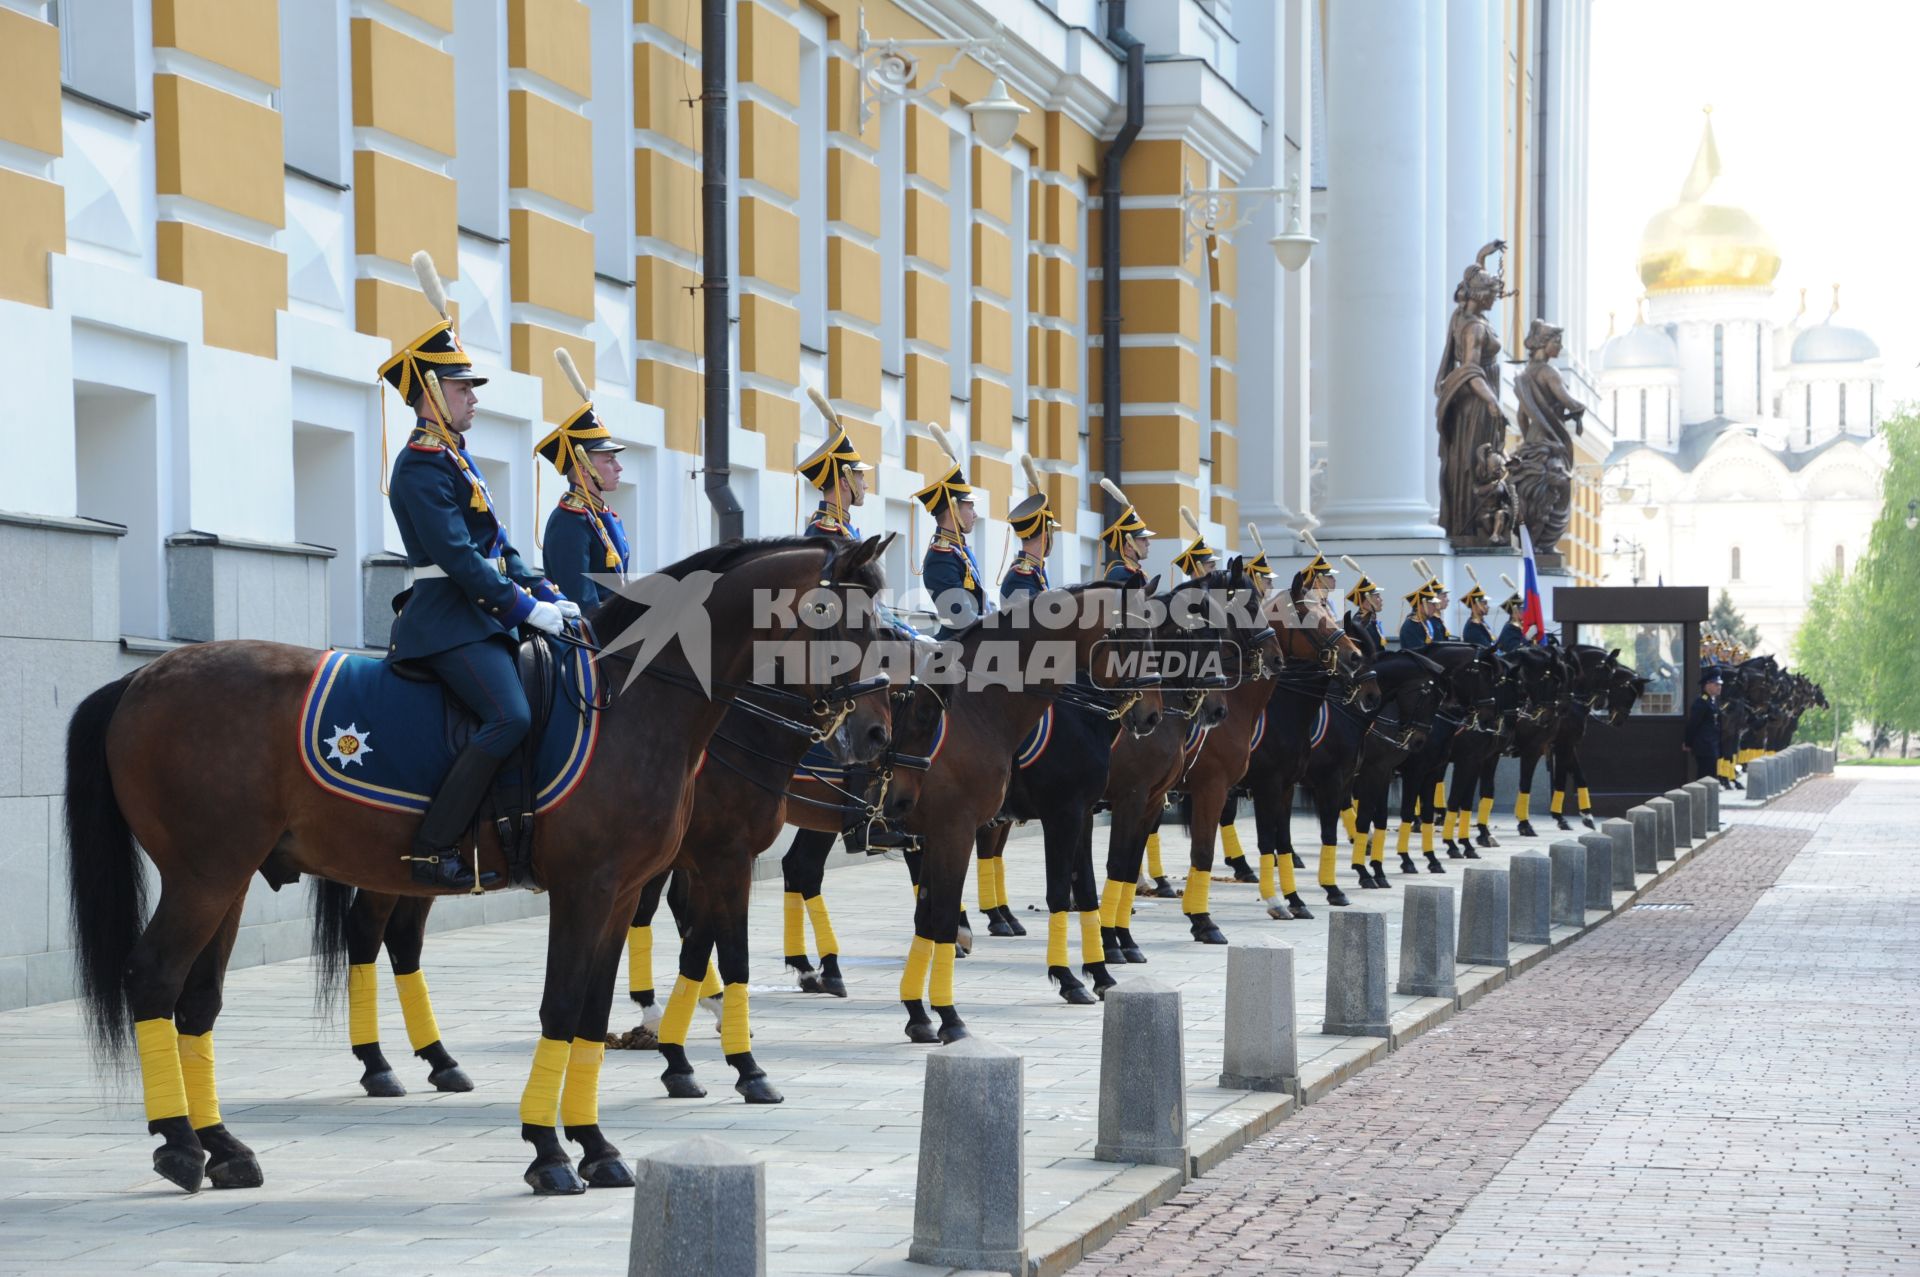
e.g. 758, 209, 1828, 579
1317, 0, 1440, 540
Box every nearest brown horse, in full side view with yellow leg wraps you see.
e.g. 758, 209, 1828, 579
67, 538, 887, 1193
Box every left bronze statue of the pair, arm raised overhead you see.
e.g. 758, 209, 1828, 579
1434, 240, 1509, 545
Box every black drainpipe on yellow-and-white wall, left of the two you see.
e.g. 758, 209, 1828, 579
701, 0, 747, 542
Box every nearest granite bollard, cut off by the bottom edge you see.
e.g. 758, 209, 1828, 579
626, 1135, 766, 1277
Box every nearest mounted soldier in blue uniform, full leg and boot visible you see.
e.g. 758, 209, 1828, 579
380, 252, 564, 891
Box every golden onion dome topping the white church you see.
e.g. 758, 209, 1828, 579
1640, 113, 1780, 292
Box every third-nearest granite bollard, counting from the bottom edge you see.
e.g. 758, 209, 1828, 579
1092, 979, 1188, 1179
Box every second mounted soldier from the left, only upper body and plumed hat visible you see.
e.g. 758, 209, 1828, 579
534, 348, 632, 609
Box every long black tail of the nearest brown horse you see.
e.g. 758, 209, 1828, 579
67, 674, 146, 1058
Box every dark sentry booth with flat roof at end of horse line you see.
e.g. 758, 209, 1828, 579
1553, 586, 1709, 816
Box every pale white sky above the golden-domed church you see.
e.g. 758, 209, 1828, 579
1588, 0, 1920, 399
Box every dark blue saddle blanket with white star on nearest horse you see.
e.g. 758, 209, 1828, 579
300, 647, 599, 812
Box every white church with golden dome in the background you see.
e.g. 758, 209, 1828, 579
1594, 115, 1891, 655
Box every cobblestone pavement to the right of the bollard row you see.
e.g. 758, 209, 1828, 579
1077, 776, 1920, 1277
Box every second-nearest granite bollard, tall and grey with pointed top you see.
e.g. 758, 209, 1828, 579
910, 1037, 1029, 1275
